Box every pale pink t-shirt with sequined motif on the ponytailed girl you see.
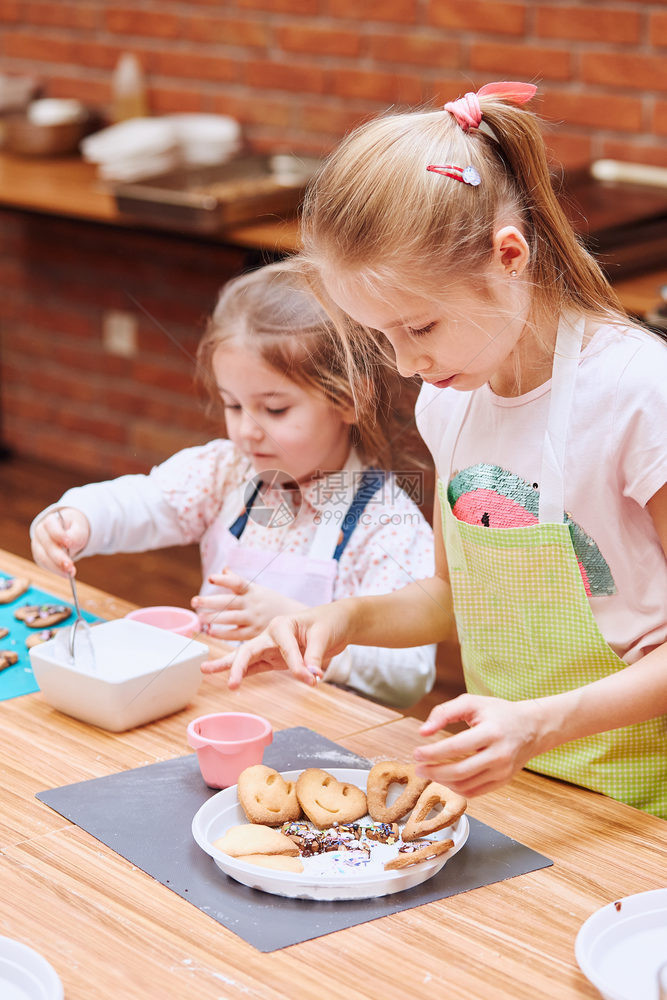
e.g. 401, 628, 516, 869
416, 325, 667, 663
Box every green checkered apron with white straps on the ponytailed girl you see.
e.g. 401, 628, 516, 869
438, 317, 667, 819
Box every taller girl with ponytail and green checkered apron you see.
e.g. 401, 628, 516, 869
223, 83, 667, 817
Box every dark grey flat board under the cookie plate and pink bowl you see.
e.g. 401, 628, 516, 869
37, 727, 553, 952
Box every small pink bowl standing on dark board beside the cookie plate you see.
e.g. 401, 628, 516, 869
188, 712, 273, 788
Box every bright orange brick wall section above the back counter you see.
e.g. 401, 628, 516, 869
0, 0, 667, 165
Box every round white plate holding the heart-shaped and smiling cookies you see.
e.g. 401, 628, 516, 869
192, 768, 469, 900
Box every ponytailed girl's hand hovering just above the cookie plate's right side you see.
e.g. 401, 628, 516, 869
414, 694, 541, 797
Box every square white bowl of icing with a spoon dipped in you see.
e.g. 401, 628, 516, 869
30, 618, 209, 733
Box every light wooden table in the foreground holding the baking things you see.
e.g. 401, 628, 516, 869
0, 551, 667, 1000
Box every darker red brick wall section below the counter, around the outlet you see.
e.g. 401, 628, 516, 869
0, 212, 247, 479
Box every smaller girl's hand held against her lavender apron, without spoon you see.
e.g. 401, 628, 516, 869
192, 569, 306, 641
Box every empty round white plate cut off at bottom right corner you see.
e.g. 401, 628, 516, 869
574, 889, 667, 1000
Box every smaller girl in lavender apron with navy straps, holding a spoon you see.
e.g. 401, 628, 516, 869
31, 262, 435, 705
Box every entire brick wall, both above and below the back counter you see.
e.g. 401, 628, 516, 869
0, 0, 667, 478
